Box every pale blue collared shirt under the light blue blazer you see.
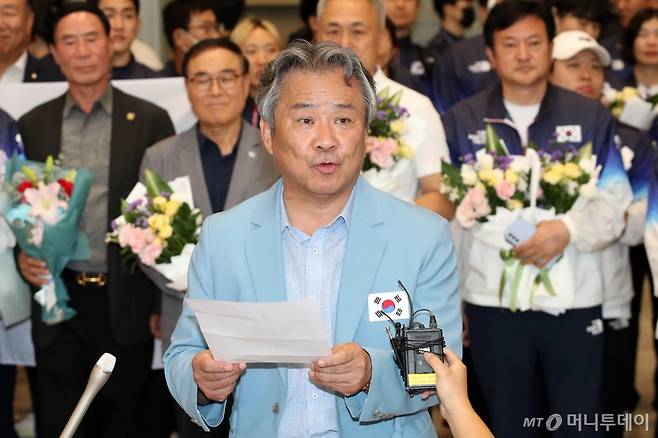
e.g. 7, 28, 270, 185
279, 192, 354, 438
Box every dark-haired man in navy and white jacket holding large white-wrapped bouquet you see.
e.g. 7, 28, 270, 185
443, 0, 631, 437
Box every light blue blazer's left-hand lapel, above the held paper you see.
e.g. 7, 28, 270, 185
246, 179, 287, 385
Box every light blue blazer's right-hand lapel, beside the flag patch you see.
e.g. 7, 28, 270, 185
336, 177, 386, 344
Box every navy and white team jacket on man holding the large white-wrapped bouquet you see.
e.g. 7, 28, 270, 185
442, 85, 632, 308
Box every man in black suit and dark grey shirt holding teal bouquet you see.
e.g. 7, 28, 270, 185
18, 3, 174, 437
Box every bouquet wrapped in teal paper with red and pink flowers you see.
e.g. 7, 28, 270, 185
4, 155, 93, 325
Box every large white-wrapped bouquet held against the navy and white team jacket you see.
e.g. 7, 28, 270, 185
441, 125, 600, 314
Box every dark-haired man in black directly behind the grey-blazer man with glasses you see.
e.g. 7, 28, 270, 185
160, 0, 220, 77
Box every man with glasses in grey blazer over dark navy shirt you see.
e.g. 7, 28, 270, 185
142, 38, 278, 438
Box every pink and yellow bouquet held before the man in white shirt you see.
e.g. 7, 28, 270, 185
362, 88, 424, 191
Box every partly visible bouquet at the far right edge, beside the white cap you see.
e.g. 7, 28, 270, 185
602, 84, 658, 131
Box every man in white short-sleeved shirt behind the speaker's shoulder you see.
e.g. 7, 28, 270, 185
316, 0, 454, 219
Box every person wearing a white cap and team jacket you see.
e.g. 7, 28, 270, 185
551, 31, 653, 437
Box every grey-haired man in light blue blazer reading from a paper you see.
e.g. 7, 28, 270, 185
164, 42, 462, 438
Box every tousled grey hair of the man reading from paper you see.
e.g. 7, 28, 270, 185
256, 40, 377, 132
